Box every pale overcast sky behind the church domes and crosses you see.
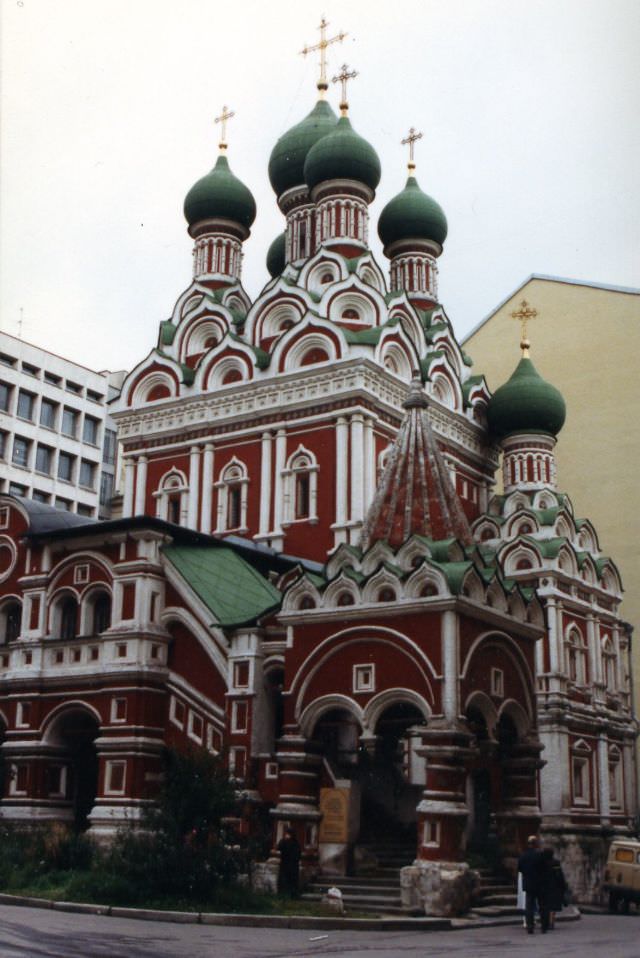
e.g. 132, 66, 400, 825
0, 0, 640, 369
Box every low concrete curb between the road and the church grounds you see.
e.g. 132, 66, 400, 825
0, 893, 581, 931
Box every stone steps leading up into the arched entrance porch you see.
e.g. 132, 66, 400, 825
302, 843, 415, 915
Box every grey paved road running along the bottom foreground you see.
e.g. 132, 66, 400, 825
0, 906, 640, 958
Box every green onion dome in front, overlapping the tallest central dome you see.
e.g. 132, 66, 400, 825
304, 116, 381, 190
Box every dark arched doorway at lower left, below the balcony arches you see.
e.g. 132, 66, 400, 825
47, 708, 100, 829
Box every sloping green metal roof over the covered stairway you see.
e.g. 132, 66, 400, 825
163, 545, 281, 627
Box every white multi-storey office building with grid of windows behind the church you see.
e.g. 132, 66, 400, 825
0, 332, 125, 519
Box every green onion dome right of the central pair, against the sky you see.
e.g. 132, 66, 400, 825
378, 176, 448, 247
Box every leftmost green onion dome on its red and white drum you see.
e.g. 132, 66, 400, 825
184, 153, 256, 230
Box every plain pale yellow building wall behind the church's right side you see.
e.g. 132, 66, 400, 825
463, 273, 640, 688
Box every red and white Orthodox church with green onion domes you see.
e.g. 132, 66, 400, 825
0, 32, 637, 913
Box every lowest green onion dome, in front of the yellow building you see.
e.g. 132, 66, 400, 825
487, 356, 567, 439
